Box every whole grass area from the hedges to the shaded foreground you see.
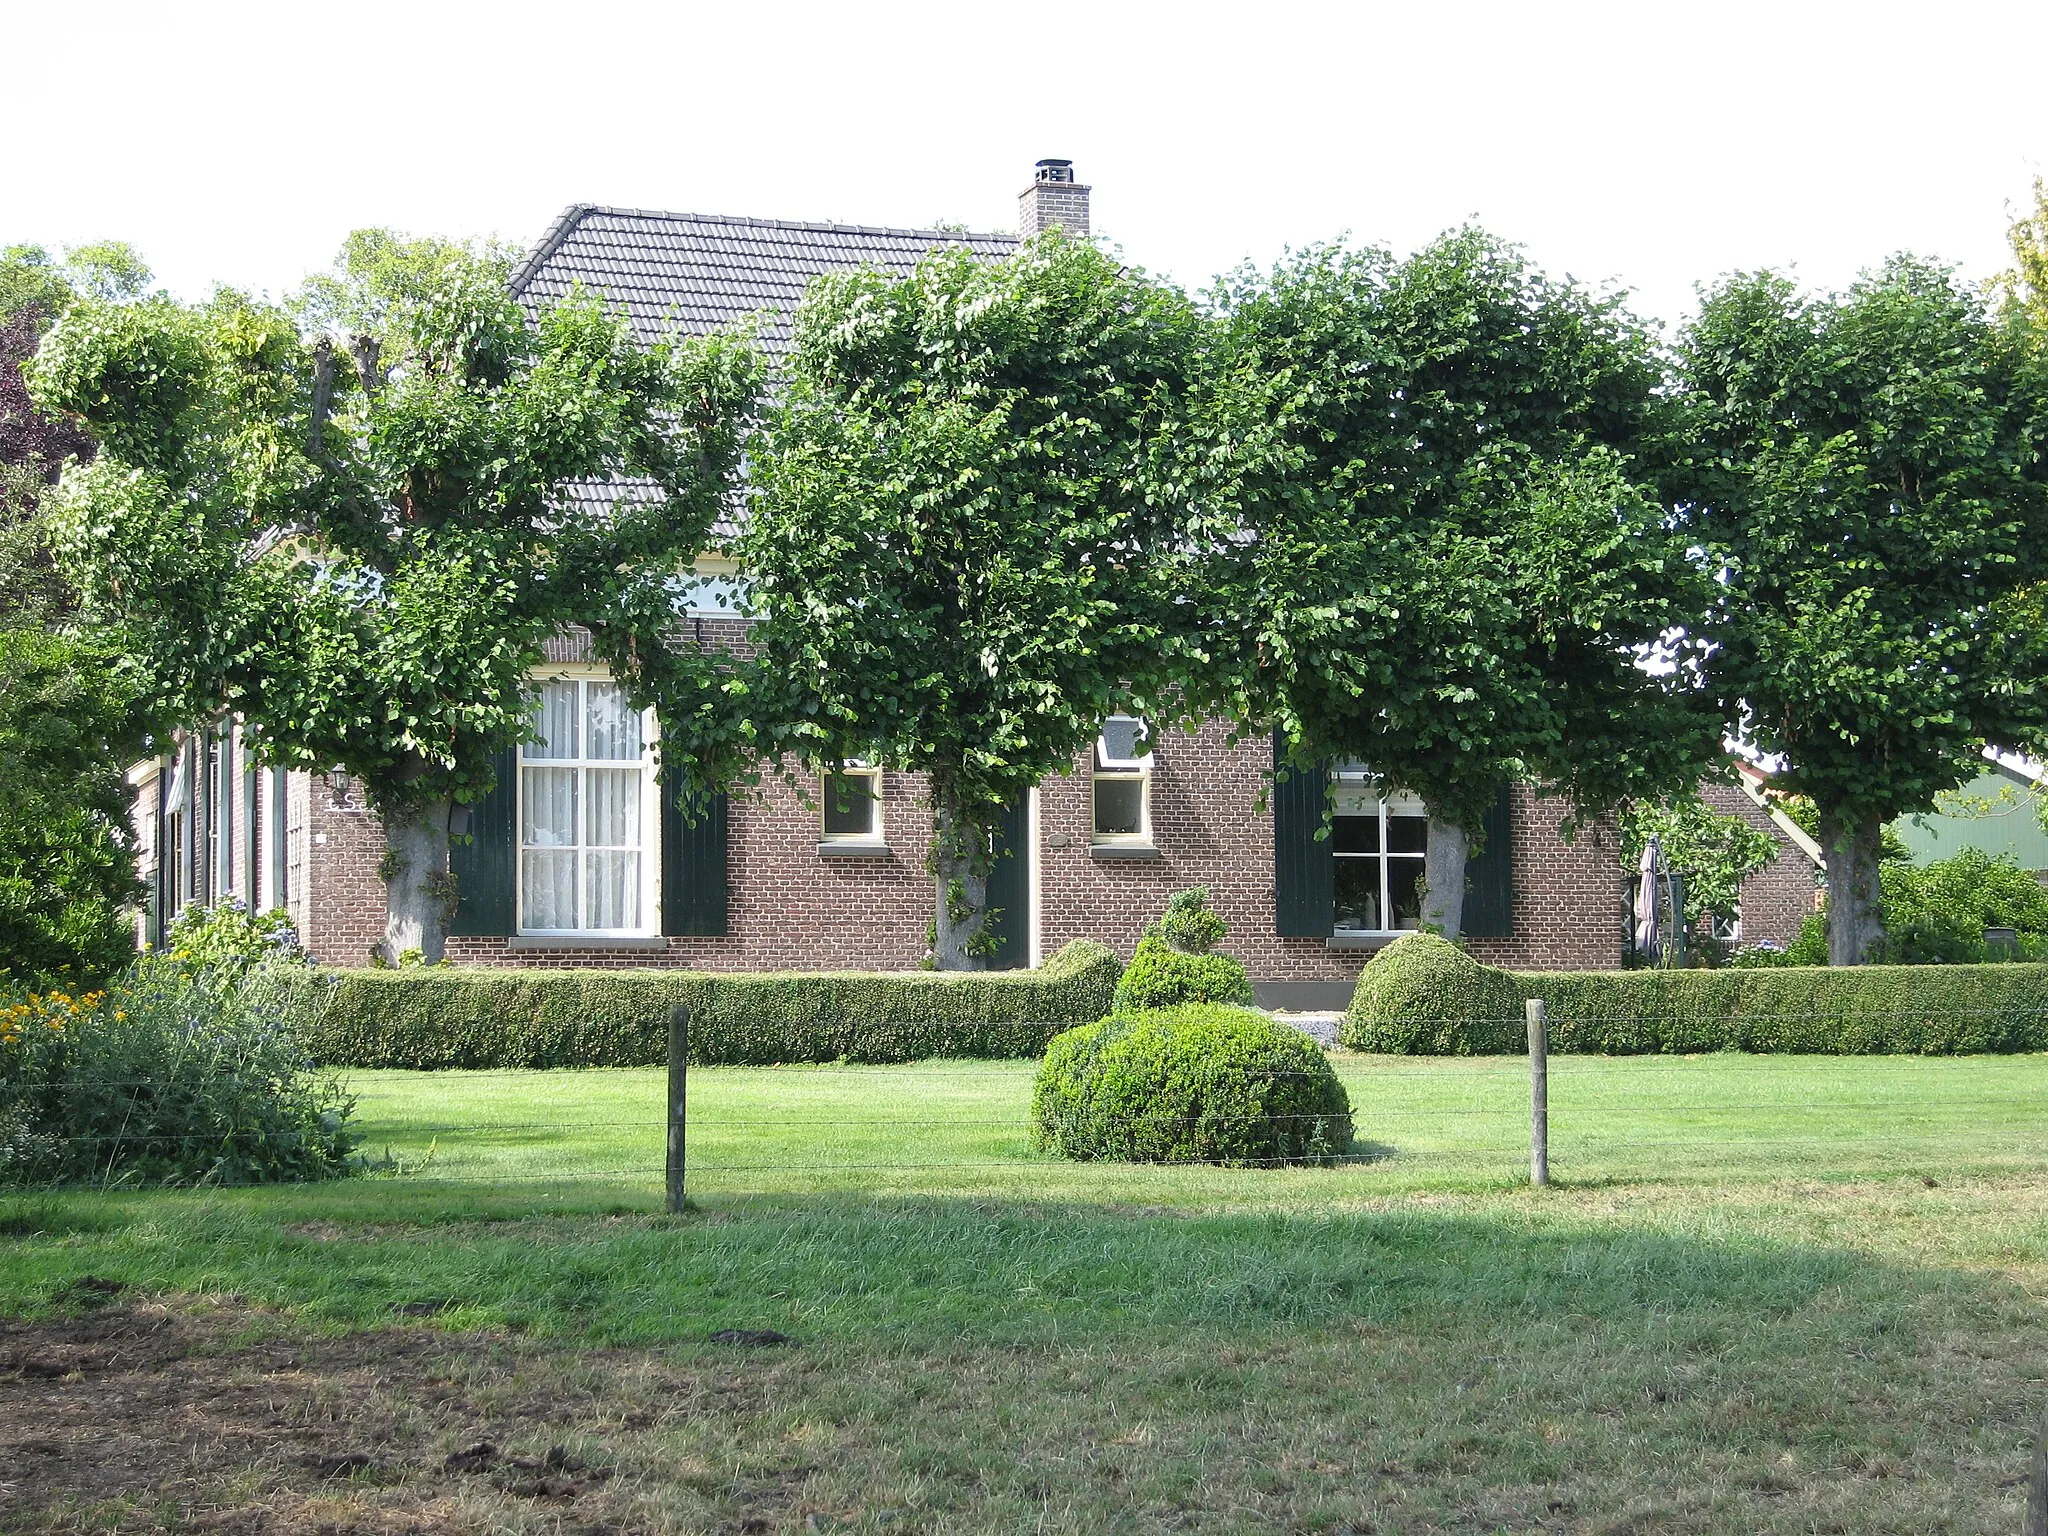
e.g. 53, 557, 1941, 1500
0, 1057, 2048, 1536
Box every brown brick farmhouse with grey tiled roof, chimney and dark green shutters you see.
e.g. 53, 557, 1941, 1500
131, 162, 1796, 1006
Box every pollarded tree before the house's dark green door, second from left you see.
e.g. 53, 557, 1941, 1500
735, 236, 1200, 969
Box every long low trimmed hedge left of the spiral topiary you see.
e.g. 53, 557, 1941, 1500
274, 940, 1120, 1069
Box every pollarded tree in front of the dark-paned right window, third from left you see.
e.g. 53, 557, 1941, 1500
1204, 229, 1720, 936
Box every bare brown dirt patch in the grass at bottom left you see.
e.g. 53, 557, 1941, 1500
0, 1307, 688, 1536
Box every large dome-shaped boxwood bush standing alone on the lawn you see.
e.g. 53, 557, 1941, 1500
1032, 1004, 1352, 1167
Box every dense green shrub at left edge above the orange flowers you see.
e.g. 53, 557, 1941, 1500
0, 629, 143, 987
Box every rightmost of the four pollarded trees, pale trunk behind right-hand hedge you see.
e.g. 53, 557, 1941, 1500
1683, 258, 2048, 965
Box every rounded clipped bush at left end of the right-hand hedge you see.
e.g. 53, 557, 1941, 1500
1339, 934, 1528, 1057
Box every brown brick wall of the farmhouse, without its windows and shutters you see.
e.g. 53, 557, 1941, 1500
295, 716, 1622, 983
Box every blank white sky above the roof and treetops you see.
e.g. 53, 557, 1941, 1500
0, 0, 2048, 331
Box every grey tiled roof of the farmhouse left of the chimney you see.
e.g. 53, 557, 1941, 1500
512, 203, 1018, 354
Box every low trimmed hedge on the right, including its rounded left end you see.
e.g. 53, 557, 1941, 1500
1343, 934, 2048, 1057
